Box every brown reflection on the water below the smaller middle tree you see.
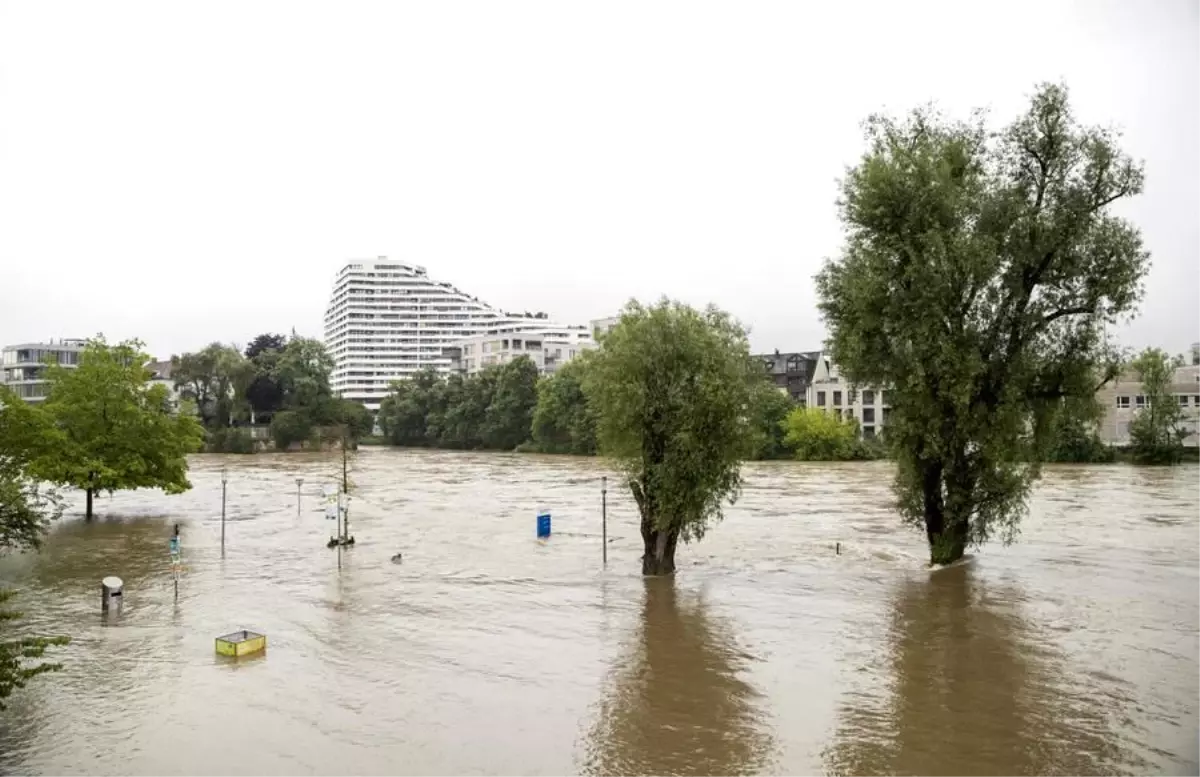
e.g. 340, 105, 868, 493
584, 578, 770, 777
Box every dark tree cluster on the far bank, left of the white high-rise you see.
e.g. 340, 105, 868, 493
172, 333, 374, 453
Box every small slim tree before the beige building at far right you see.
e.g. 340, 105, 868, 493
1129, 348, 1188, 464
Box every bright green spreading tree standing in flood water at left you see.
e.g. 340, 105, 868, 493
30, 337, 204, 518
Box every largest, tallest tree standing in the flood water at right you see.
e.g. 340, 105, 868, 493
817, 85, 1150, 564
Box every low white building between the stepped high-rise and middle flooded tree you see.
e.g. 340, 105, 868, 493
455, 326, 596, 375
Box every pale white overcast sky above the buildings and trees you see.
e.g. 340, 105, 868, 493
0, 0, 1200, 357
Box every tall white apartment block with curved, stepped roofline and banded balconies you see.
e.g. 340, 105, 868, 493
325, 257, 592, 410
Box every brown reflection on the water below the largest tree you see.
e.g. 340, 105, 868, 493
826, 564, 1145, 777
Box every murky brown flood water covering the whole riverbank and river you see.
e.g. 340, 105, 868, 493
0, 450, 1200, 777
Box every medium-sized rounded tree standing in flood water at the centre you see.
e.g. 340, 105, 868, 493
584, 300, 761, 574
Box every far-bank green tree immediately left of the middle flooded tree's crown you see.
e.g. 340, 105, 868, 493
532, 353, 596, 456
